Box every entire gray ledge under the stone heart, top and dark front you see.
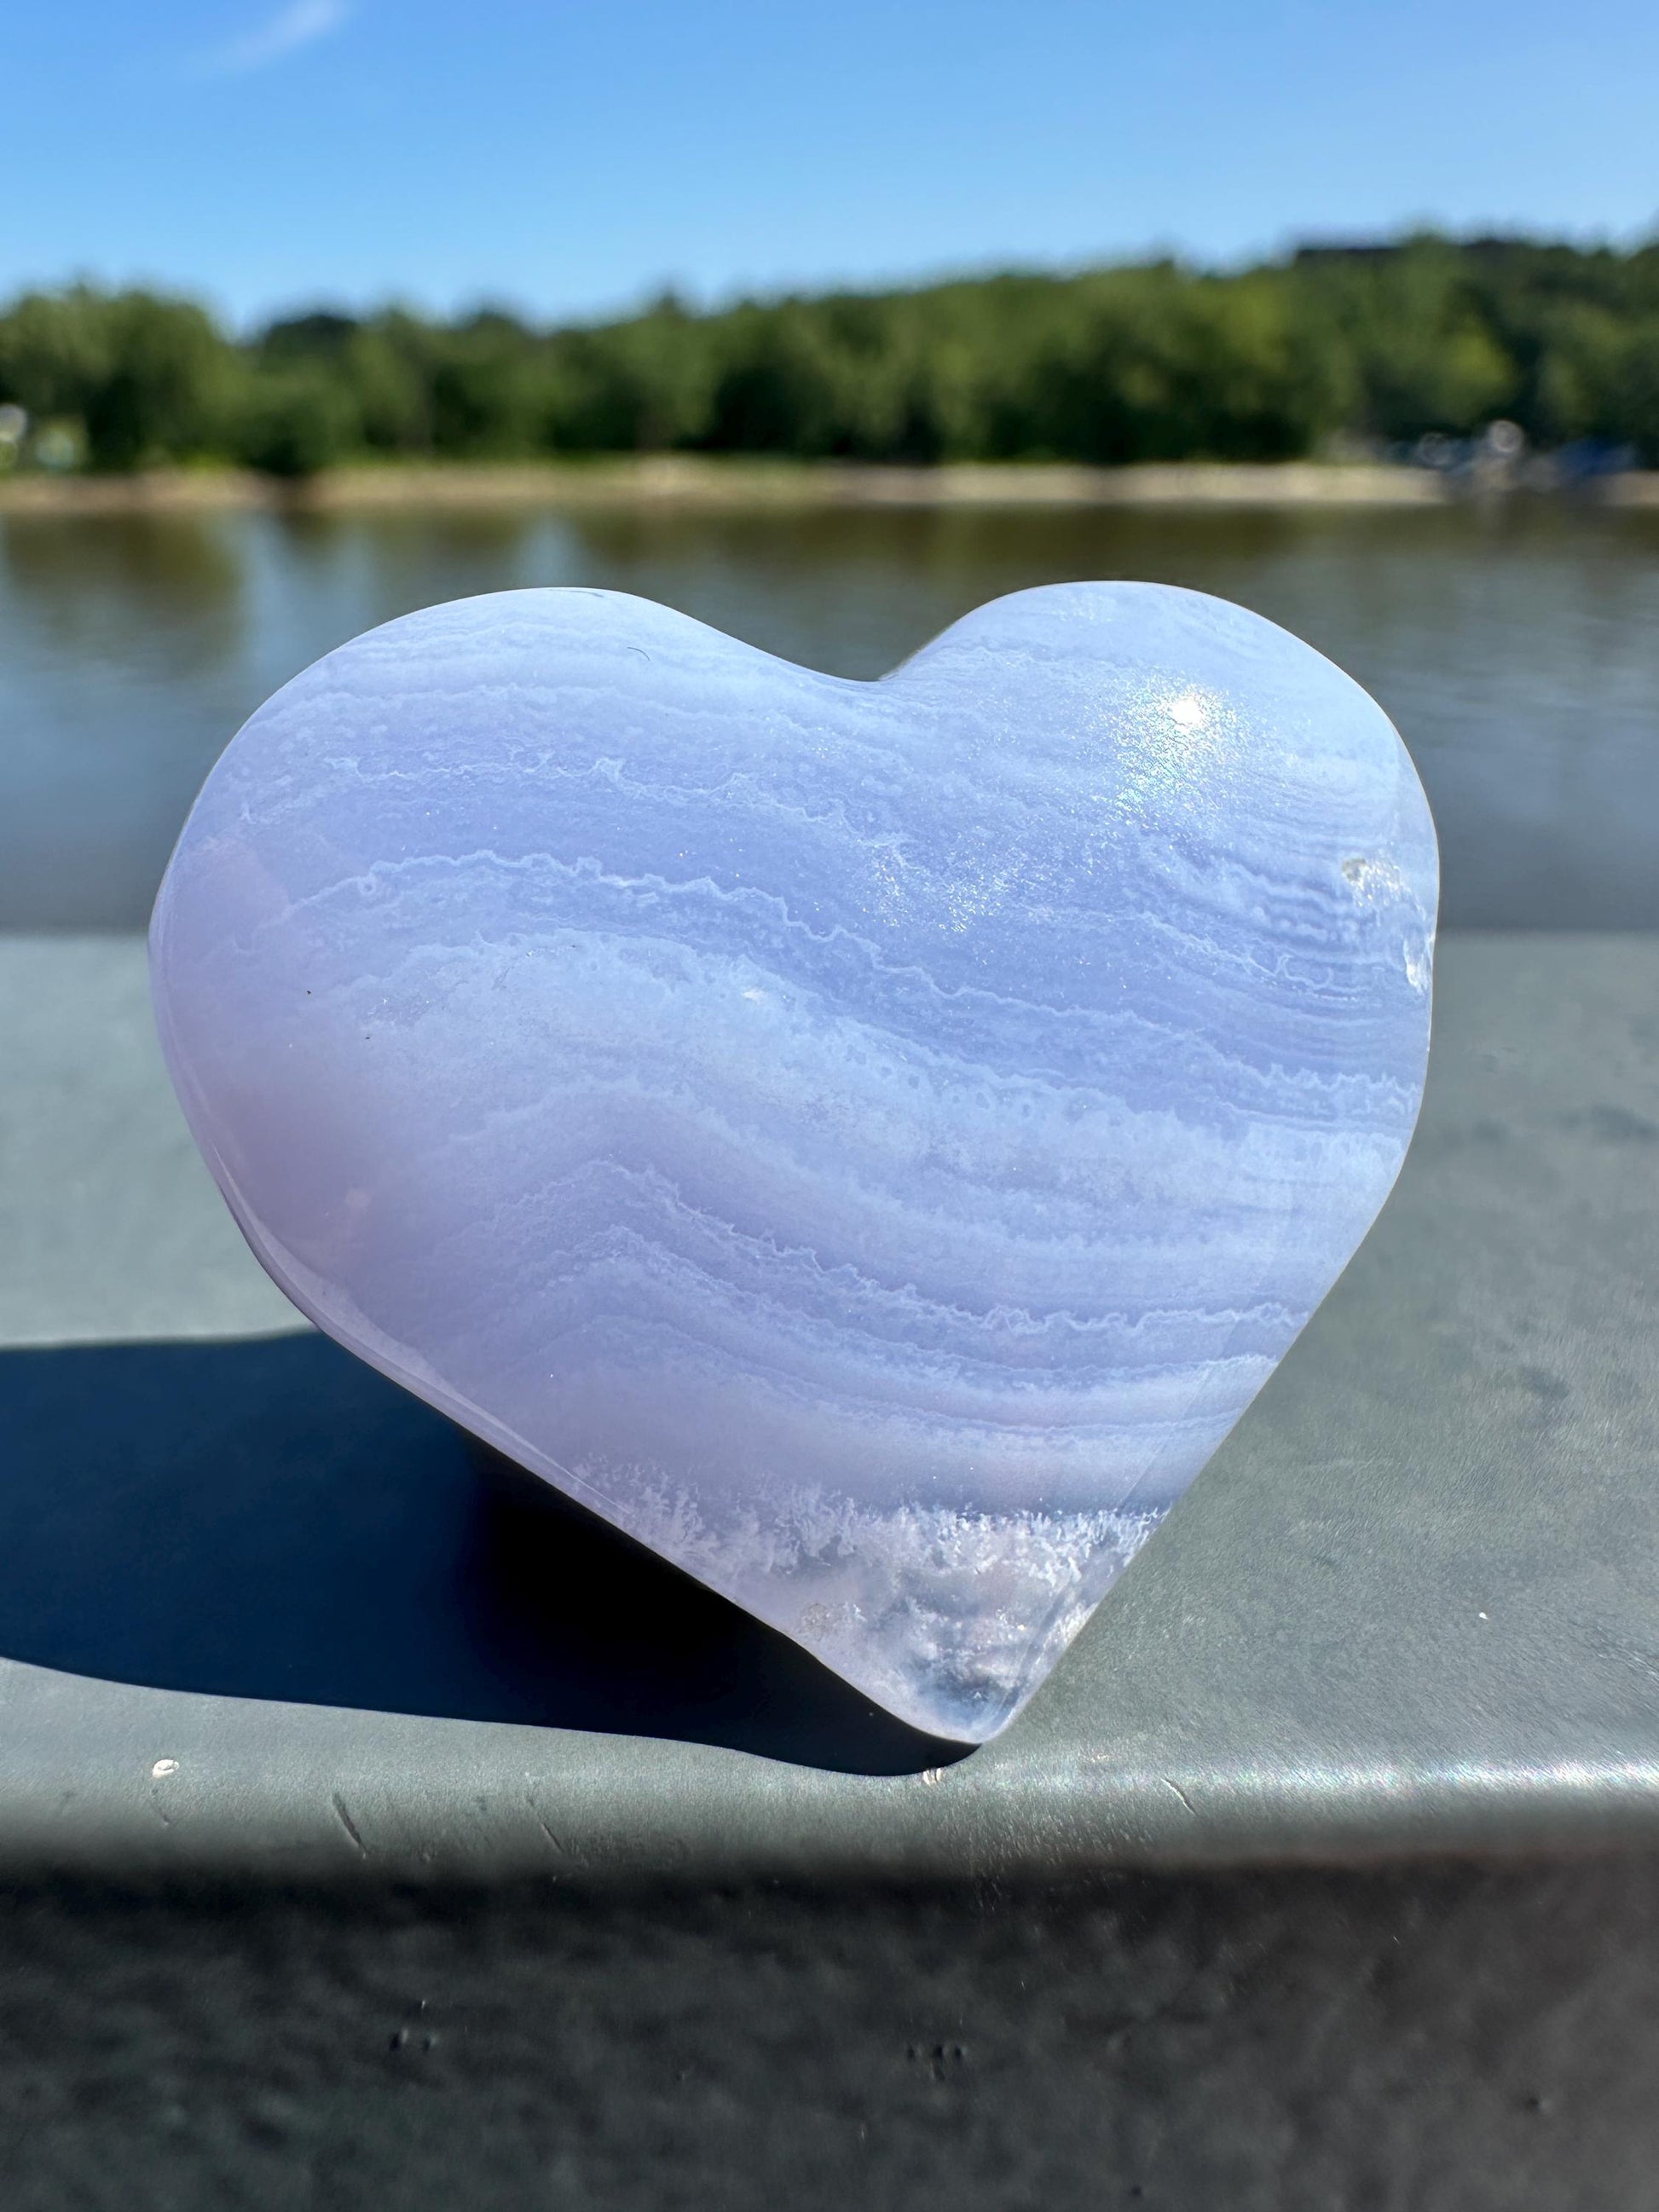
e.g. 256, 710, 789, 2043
0, 938, 1659, 2212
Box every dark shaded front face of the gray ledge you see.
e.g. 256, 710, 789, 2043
0, 1860, 1659, 2212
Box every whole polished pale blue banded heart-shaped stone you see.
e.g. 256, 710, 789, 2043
153, 584, 1436, 1739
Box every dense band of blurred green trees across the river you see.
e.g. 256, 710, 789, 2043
0, 237, 1659, 476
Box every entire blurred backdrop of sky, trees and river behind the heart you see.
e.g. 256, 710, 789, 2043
0, 0, 1659, 931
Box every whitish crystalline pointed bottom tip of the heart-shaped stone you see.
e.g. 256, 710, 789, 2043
552, 1469, 1164, 1743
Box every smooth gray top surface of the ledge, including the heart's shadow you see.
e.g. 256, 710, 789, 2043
0, 936, 1659, 1882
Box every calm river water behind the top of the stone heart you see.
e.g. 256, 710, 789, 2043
0, 500, 1659, 929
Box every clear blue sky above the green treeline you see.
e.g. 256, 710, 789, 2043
0, 0, 1659, 321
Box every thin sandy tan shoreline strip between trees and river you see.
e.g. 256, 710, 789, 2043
0, 453, 1659, 516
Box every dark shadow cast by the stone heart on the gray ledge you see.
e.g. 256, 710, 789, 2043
0, 1336, 962, 1774
